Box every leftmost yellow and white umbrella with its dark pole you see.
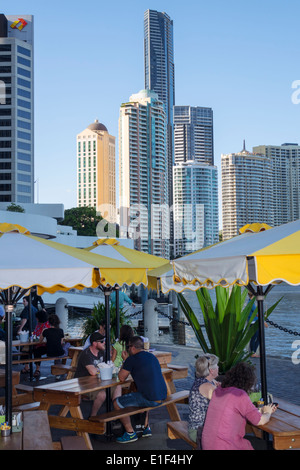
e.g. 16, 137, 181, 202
0, 223, 152, 422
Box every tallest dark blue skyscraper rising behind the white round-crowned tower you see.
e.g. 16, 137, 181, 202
144, 10, 175, 236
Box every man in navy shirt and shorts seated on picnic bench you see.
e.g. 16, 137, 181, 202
114, 336, 167, 443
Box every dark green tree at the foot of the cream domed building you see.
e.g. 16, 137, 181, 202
59, 206, 103, 237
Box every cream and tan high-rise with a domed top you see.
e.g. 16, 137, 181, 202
77, 120, 116, 223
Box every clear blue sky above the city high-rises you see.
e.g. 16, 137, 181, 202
1, 0, 300, 223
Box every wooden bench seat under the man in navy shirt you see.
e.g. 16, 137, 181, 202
89, 390, 189, 423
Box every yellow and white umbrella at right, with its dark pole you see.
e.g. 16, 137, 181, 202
172, 220, 300, 408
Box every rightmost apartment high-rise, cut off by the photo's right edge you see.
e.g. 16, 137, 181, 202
253, 143, 300, 226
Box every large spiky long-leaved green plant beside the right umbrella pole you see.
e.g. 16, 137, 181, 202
178, 285, 281, 374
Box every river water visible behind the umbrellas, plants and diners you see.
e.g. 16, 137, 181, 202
68, 284, 300, 358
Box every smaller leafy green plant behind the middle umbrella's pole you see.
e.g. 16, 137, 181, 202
82, 302, 134, 341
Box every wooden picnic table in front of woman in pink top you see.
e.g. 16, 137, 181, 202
251, 398, 300, 450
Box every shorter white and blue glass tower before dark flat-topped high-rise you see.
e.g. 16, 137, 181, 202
173, 161, 219, 256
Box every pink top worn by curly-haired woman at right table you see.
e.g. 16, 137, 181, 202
201, 387, 261, 450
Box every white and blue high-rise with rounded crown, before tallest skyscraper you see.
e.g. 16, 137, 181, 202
119, 90, 170, 258
